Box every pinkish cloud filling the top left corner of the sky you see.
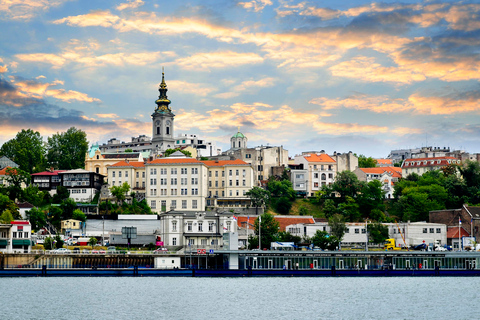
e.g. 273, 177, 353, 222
0, 0, 70, 20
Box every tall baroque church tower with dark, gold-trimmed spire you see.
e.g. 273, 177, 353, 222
152, 72, 175, 153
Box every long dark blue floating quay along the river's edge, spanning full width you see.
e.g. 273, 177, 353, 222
0, 250, 480, 277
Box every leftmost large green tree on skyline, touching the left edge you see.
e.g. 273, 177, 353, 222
0, 129, 46, 174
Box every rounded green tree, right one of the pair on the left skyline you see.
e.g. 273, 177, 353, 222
47, 127, 88, 170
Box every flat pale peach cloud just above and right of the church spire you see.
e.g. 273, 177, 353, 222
175, 51, 263, 70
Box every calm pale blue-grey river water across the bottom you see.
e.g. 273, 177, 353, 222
0, 277, 480, 320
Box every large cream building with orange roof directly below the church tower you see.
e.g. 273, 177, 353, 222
145, 151, 208, 213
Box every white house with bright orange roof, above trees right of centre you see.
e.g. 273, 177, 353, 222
295, 153, 337, 197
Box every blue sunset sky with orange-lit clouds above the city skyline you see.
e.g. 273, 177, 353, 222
0, 0, 480, 158
